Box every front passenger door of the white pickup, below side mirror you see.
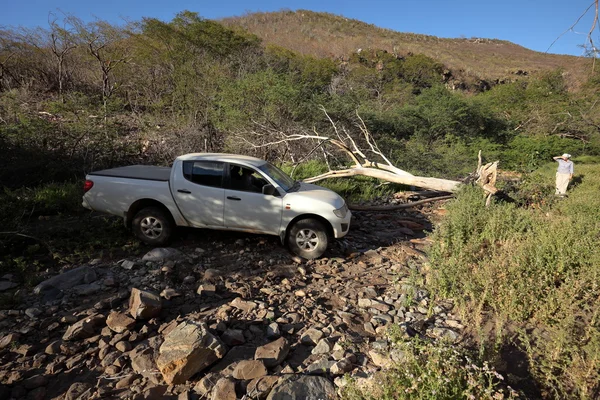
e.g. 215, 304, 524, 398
225, 164, 283, 235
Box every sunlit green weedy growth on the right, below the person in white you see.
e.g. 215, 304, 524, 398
428, 163, 600, 399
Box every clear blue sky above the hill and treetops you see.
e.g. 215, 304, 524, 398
0, 0, 600, 55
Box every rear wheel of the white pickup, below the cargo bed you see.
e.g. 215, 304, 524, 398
131, 207, 175, 246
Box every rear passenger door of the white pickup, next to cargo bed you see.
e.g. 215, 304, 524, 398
172, 161, 225, 227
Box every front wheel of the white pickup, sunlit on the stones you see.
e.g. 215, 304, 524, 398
287, 218, 329, 260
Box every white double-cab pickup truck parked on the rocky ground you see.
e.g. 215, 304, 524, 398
83, 153, 351, 259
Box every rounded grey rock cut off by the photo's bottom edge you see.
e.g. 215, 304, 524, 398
267, 375, 337, 400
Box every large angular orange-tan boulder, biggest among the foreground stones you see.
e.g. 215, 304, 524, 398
156, 321, 226, 385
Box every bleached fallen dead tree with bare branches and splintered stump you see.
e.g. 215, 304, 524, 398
238, 107, 498, 193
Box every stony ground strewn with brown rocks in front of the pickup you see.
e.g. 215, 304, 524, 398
0, 199, 462, 400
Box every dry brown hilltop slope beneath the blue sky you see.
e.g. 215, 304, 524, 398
221, 10, 590, 87
